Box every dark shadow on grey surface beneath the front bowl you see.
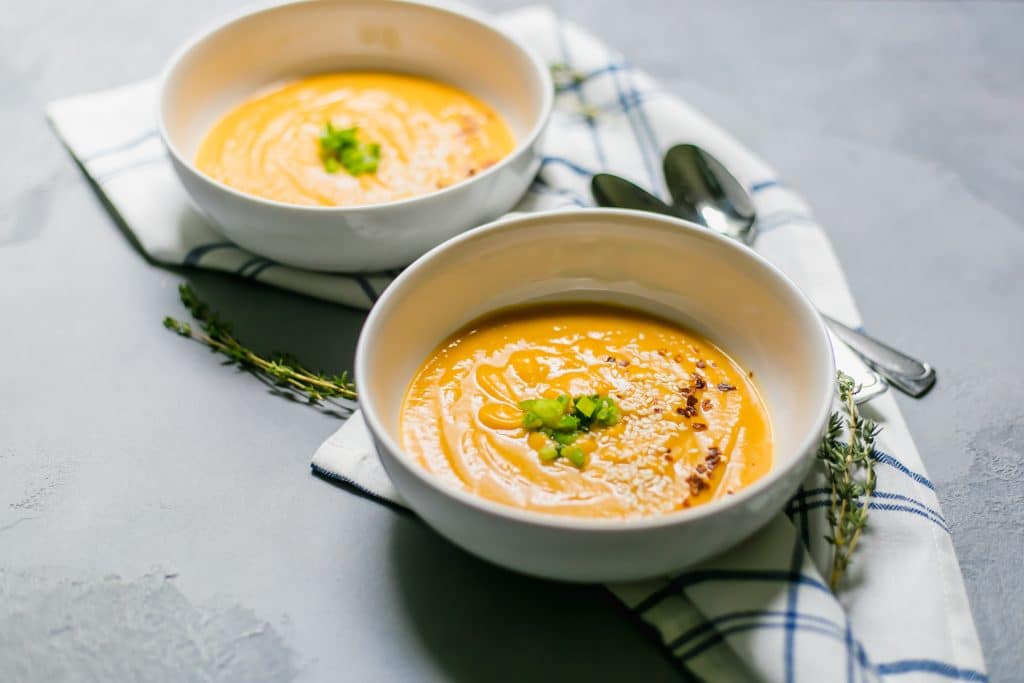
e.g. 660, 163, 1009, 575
382, 516, 686, 683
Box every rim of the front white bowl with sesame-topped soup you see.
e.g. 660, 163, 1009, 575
354, 208, 836, 532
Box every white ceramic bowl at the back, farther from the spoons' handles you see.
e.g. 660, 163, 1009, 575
159, 0, 553, 271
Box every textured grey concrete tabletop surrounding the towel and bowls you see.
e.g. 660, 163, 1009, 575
0, 0, 1024, 681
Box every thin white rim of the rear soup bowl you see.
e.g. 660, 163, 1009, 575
157, 0, 555, 214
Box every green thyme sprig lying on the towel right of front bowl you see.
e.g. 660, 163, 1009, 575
818, 372, 881, 591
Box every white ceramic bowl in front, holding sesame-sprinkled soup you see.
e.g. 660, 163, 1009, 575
355, 210, 835, 582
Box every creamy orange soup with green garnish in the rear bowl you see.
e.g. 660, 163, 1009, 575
196, 73, 515, 206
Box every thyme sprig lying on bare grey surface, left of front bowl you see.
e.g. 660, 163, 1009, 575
164, 283, 356, 405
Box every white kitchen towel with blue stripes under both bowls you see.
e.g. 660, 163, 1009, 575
48, 7, 987, 683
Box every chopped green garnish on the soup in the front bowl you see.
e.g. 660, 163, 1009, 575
519, 393, 622, 468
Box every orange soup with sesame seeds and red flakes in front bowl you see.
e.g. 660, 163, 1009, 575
401, 304, 772, 518
